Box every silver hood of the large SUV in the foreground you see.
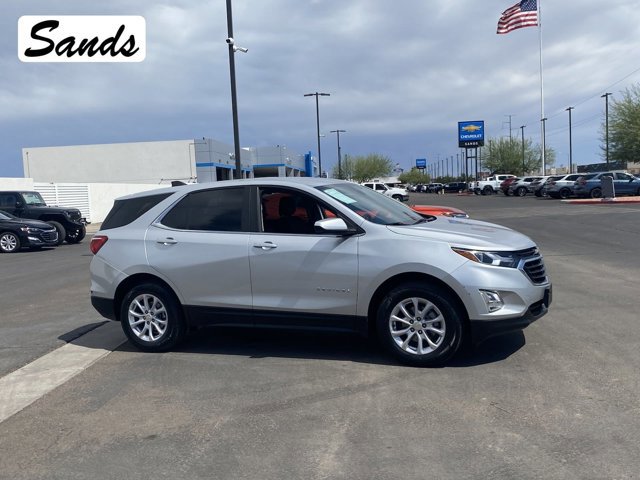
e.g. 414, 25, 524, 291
387, 217, 536, 251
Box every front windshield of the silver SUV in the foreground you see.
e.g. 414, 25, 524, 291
317, 183, 426, 225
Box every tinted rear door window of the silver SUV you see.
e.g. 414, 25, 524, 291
161, 187, 244, 232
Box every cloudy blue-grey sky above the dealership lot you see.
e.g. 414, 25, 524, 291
0, 0, 640, 177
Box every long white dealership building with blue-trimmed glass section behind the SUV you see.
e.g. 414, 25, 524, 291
22, 138, 317, 184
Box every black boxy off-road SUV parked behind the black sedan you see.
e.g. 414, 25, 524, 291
0, 191, 87, 245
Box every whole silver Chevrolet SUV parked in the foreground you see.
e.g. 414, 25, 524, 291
91, 178, 551, 366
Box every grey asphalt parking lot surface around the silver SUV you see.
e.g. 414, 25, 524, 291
0, 194, 640, 479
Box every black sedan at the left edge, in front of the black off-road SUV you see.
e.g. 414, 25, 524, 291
0, 211, 58, 253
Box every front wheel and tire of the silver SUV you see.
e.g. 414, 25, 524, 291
376, 282, 463, 367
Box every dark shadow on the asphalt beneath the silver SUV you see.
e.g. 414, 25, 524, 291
118, 327, 525, 368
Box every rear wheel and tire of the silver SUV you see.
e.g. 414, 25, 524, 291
120, 283, 186, 352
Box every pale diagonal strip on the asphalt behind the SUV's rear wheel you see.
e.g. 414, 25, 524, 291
0, 322, 126, 423
